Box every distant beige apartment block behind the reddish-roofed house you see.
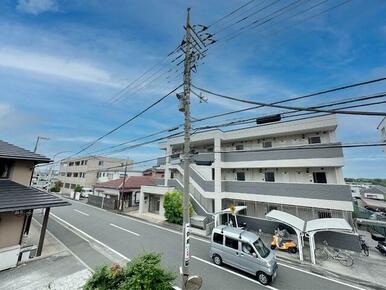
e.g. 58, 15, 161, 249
58, 156, 132, 194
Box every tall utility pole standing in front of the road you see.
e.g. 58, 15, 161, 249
181, 8, 191, 290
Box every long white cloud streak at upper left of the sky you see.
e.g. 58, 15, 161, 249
0, 47, 122, 87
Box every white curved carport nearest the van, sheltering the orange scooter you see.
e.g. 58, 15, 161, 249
265, 210, 305, 261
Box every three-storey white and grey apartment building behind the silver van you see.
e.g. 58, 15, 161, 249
153, 115, 353, 221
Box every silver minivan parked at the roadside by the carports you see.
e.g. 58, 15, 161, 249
209, 225, 278, 285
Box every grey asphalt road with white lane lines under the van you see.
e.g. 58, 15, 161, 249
36, 201, 361, 290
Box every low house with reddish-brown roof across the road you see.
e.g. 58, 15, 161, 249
88, 176, 155, 211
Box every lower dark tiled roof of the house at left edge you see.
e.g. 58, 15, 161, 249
0, 179, 70, 212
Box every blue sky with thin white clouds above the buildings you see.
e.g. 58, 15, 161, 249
0, 0, 386, 178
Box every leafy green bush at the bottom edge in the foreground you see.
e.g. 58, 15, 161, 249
83, 253, 175, 290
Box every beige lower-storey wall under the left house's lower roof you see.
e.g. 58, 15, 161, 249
0, 213, 25, 249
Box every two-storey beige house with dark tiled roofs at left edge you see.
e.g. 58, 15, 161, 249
0, 140, 69, 270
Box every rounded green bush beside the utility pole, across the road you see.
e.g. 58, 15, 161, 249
164, 191, 193, 225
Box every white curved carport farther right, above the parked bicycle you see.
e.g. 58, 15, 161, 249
305, 218, 353, 264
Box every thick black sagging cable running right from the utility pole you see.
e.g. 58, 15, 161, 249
192, 85, 386, 116
